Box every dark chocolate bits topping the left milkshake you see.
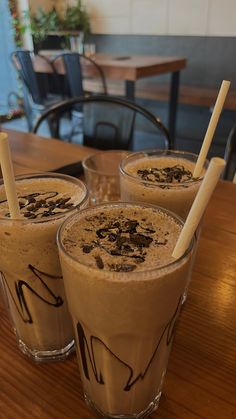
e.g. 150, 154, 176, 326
0, 191, 75, 219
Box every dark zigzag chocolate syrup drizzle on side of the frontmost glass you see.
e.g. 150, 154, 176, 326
77, 295, 183, 391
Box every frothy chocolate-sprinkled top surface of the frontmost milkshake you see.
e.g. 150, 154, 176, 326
63, 207, 181, 272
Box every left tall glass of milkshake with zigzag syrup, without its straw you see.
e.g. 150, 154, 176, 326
0, 174, 87, 361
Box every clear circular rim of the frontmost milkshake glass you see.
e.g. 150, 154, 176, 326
56, 201, 195, 282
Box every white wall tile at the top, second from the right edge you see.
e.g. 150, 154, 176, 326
168, 0, 208, 36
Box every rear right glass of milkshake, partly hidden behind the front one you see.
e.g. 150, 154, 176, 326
120, 150, 206, 223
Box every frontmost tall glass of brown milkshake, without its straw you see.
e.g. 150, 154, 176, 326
58, 203, 195, 418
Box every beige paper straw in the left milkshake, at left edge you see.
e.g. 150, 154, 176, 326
0, 132, 21, 219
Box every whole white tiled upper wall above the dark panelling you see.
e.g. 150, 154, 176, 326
84, 0, 236, 36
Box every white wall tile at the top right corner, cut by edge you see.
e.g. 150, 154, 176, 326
207, 0, 236, 36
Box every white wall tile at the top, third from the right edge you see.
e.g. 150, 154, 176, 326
131, 0, 168, 35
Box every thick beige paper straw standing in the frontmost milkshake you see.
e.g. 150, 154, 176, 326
172, 157, 225, 259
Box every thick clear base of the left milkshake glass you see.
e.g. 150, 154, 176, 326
17, 339, 75, 362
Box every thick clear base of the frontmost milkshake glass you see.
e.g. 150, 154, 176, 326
84, 391, 161, 419
